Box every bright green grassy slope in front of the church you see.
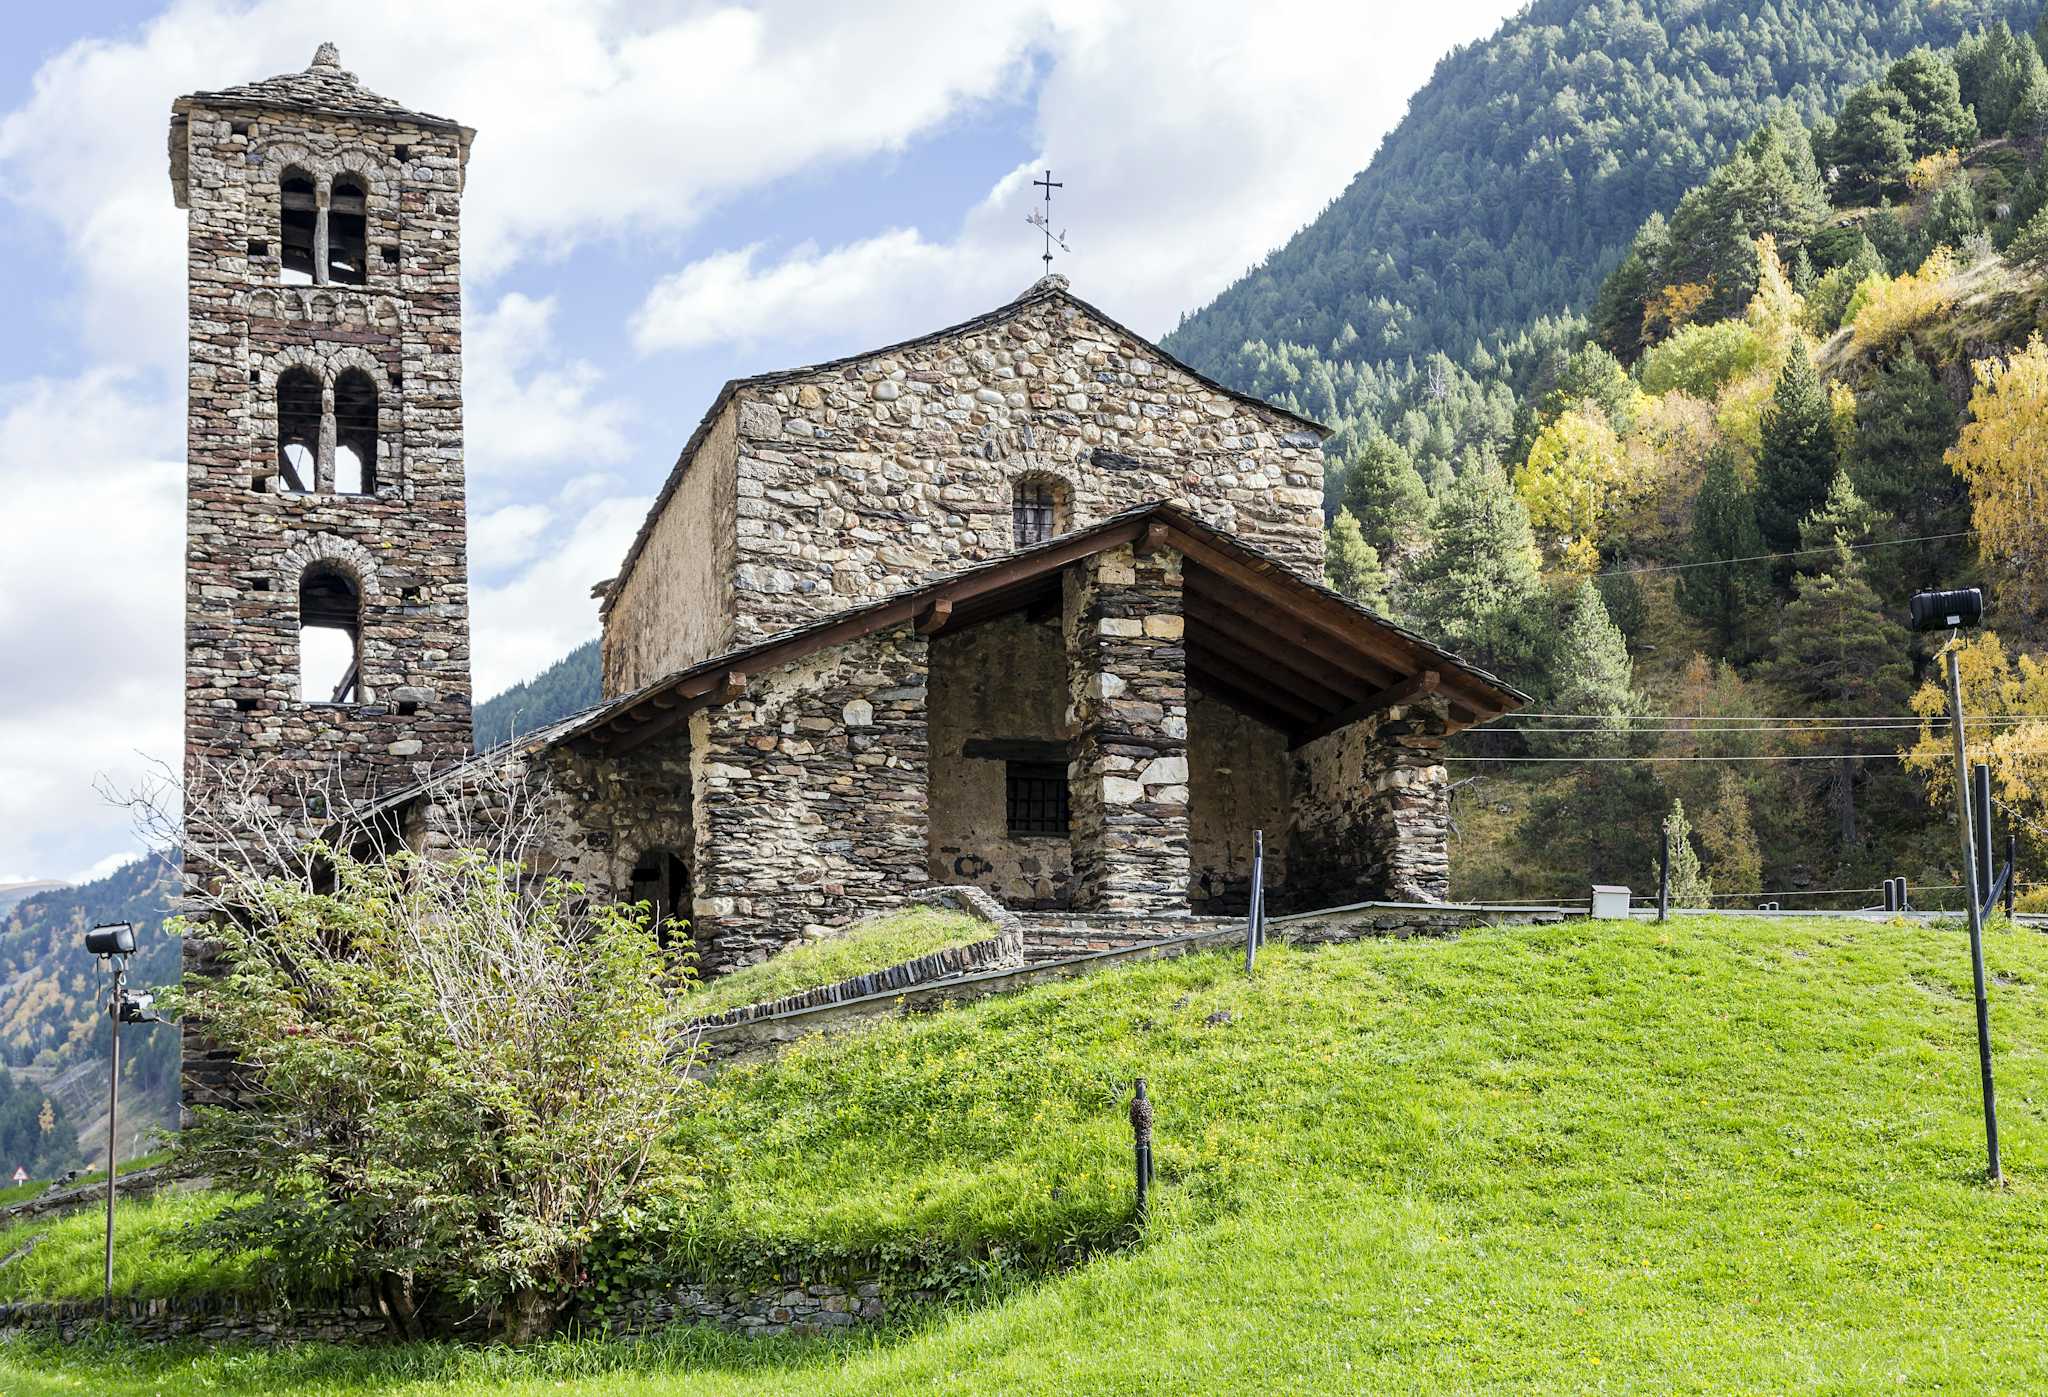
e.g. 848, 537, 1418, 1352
12, 918, 2048, 1395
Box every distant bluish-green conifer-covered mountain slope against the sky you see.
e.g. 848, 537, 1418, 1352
1165, 0, 2038, 401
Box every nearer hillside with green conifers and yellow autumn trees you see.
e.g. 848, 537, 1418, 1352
1331, 23, 2048, 905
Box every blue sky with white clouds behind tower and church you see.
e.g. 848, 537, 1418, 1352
0, 0, 1513, 881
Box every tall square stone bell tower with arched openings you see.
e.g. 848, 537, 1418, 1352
170, 43, 475, 1100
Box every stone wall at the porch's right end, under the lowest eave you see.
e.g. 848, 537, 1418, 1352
1276, 694, 1450, 912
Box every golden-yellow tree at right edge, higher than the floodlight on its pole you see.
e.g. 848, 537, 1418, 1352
1948, 334, 2048, 608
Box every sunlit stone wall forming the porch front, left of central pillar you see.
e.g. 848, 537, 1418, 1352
690, 625, 930, 973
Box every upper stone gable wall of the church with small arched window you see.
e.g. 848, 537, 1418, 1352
606, 279, 1323, 667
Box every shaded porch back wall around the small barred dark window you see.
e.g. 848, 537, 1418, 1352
930, 615, 1073, 907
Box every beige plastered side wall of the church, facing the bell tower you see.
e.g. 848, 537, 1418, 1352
604, 404, 737, 699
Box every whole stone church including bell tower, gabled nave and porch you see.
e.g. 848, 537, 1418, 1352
170, 45, 1524, 1011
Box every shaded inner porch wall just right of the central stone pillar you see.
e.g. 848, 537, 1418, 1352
1188, 690, 1290, 914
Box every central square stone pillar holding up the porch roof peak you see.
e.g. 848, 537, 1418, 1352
1063, 545, 1188, 912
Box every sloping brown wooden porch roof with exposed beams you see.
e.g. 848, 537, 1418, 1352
549, 504, 1528, 754
